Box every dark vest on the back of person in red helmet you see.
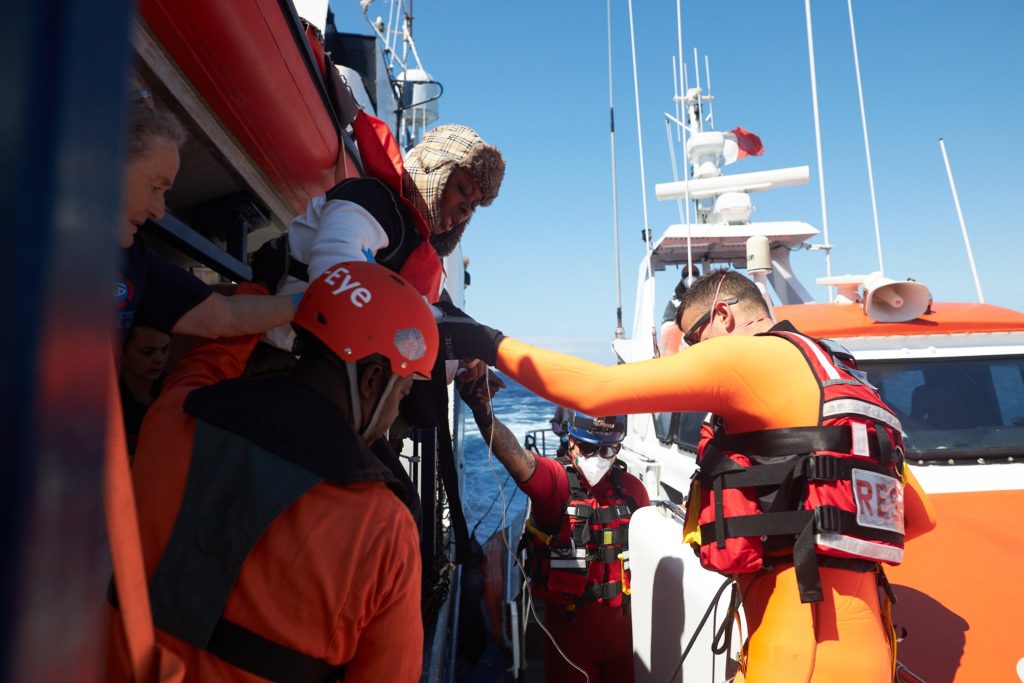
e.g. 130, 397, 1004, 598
109, 377, 420, 683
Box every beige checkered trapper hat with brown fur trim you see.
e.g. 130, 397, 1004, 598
403, 124, 505, 256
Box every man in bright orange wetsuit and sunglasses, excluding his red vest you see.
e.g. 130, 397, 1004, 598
440, 271, 935, 683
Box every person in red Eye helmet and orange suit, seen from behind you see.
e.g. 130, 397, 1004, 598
109, 262, 437, 683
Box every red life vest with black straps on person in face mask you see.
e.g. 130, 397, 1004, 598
520, 457, 638, 607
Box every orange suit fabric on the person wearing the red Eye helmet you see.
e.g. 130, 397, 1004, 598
108, 284, 423, 683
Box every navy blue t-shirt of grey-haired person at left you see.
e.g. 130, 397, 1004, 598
114, 234, 213, 342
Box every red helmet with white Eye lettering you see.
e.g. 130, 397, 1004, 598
292, 261, 437, 378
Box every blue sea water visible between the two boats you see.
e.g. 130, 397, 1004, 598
462, 376, 558, 544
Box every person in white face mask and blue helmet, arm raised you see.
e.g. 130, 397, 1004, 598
460, 377, 650, 683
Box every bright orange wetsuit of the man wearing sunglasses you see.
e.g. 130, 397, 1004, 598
497, 336, 935, 683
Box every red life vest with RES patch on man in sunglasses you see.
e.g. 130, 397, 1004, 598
690, 328, 903, 602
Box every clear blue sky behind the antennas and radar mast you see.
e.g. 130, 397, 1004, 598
331, 0, 1024, 362
